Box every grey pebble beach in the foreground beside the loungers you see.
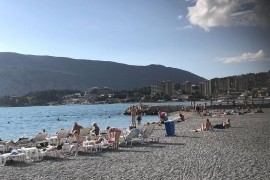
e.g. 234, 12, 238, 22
0, 109, 270, 179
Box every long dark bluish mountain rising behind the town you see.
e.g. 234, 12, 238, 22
0, 53, 205, 96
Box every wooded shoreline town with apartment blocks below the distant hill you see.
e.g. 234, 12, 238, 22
0, 71, 270, 106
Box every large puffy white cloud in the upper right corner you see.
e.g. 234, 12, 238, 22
187, 0, 270, 31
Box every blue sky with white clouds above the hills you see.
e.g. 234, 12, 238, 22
0, 0, 270, 79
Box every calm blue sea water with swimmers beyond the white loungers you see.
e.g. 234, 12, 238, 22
0, 102, 192, 140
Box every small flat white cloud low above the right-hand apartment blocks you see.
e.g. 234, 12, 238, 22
219, 50, 269, 63
